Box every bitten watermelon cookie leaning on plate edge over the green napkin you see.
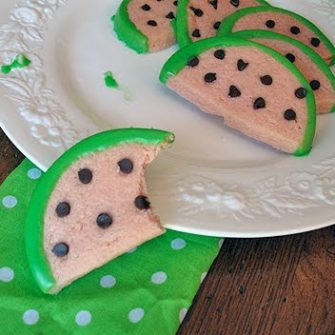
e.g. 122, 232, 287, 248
26, 128, 174, 294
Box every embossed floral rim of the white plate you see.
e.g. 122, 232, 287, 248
0, 0, 335, 237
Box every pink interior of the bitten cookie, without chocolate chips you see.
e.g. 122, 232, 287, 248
44, 144, 164, 292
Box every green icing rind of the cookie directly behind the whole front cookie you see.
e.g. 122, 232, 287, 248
231, 30, 335, 113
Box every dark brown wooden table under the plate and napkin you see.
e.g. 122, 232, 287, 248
0, 130, 335, 335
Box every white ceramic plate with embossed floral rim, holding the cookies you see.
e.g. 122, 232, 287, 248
0, 0, 335, 237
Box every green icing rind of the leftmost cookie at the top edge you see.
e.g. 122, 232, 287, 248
111, 0, 149, 54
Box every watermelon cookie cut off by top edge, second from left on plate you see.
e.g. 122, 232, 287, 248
176, 0, 267, 47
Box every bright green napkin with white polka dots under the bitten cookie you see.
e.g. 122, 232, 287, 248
0, 160, 222, 335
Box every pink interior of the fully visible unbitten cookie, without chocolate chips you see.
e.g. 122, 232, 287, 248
167, 47, 308, 153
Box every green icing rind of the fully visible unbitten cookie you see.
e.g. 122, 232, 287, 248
159, 36, 316, 156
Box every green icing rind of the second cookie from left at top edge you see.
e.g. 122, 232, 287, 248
175, 0, 270, 47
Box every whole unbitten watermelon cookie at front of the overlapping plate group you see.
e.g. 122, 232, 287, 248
160, 37, 316, 156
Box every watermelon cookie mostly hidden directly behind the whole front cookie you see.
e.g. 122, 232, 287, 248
233, 30, 335, 114
